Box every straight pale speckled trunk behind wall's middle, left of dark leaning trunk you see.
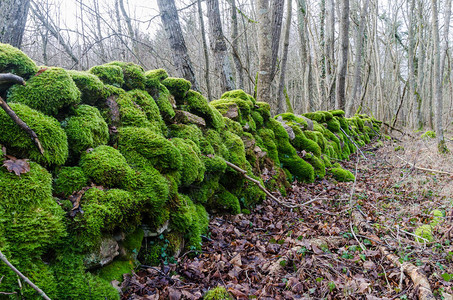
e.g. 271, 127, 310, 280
256, 0, 272, 103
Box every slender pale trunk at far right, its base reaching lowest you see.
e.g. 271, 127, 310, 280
431, 0, 448, 153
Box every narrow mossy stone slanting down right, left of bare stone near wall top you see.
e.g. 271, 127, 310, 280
128, 90, 166, 134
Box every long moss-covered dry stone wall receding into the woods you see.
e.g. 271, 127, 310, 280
0, 44, 380, 299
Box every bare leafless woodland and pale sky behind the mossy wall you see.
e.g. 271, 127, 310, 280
0, 0, 453, 148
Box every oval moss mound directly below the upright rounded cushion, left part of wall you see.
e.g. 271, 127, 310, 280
80, 146, 133, 187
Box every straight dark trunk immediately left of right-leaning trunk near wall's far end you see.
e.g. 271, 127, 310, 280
336, 0, 349, 110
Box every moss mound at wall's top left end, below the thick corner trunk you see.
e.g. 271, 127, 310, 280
0, 43, 38, 79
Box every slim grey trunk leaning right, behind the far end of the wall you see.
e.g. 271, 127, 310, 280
346, 0, 370, 116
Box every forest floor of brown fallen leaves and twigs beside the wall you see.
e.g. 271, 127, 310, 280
122, 134, 453, 299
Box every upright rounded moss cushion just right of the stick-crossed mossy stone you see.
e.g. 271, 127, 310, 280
62, 105, 109, 157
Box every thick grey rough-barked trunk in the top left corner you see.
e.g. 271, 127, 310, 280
0, 0, 30, 48
